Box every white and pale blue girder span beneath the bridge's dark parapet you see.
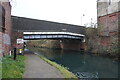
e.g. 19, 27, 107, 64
23, 32, 84, 40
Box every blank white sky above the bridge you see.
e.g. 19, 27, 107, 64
11, 0, 97, 25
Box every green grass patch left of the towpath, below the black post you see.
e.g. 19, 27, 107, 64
2, 55, 25, 78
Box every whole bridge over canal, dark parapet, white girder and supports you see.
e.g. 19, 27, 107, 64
12, 16, 85, 48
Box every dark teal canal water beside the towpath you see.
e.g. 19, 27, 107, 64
29, 47, 120, 78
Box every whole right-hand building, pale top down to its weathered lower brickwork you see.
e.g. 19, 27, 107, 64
97, 0, 120, 53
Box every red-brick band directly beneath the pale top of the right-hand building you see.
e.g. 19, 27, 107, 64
98, 12, 120, 36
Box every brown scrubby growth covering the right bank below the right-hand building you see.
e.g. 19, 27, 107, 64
85, 25, 120, 59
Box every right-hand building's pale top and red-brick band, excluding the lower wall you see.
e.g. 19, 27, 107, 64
97, 0, 120, 36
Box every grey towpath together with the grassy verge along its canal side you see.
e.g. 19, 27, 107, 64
23, 52, 77, 80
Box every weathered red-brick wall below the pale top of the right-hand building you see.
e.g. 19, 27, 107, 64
98, 12, 120, 55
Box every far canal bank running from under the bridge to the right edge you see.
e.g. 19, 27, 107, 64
27, 38, 120, 60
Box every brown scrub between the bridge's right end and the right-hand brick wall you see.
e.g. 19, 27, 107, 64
85, 27, 100, 53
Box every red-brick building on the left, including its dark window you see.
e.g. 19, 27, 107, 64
0, 0, 11, 56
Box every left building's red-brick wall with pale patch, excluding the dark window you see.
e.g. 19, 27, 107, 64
0, 0, 12, 54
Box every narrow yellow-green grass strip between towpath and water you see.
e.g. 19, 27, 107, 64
40, 56, 78, 80
